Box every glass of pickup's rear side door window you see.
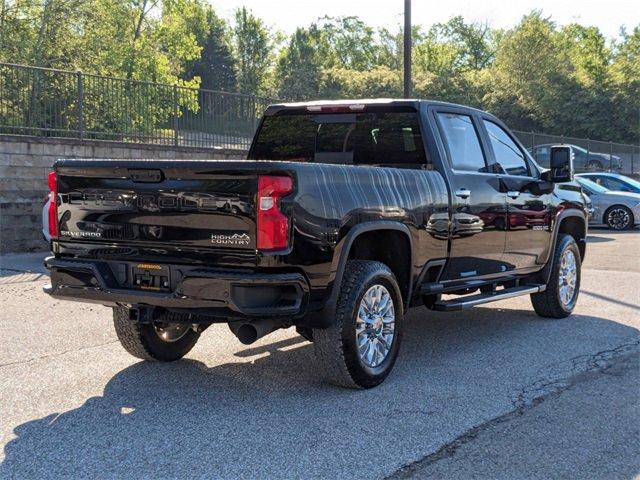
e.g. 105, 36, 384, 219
438, 113, 487, 172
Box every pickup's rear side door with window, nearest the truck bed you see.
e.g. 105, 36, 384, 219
435, 110, 507, 281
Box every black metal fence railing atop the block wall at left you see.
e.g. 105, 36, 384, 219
0, 63, 275, 149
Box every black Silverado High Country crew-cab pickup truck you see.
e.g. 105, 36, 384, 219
45, 100, 587, 388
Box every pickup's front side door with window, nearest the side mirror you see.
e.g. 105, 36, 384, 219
482, 118, 551, 270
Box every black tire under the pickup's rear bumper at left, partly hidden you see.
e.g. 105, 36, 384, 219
113, 307, 200, 362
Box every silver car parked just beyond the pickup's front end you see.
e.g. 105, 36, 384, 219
575, 175, 640, 230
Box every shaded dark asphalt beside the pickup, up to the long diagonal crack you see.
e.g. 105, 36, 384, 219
0, 308, 638, 478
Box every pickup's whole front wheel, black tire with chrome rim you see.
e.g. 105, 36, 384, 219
531, 234, 581, 318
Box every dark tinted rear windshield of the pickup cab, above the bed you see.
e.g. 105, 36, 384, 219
249, 112, 427, 167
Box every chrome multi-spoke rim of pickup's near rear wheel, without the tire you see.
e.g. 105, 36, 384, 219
356, 285, 396, 367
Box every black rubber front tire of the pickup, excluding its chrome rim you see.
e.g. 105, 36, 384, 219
531, 233, 581, 318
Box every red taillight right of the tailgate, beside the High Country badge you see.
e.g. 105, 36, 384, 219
256, 175, 293, 250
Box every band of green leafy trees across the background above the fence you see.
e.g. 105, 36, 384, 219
0, 4, 640, 142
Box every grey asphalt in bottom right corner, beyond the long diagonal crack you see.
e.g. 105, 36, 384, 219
393, 353, 640, 480
